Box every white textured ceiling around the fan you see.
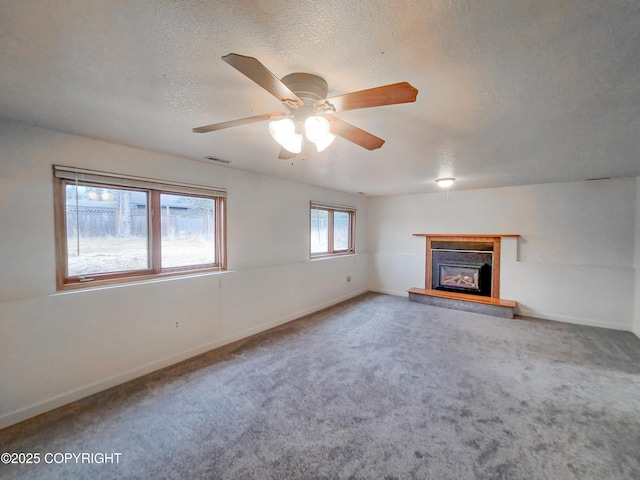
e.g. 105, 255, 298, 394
0, 0, 640, 195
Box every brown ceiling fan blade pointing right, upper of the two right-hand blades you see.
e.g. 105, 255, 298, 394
316, 82, 418, 112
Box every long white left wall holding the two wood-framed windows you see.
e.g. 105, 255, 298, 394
0, 121, 368, 427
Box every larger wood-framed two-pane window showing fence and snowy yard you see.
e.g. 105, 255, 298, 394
54, 165, 226, 288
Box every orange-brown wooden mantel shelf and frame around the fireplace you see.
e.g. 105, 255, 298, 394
413, 233, 520, 303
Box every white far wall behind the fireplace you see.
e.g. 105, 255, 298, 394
367, 178, 640, 330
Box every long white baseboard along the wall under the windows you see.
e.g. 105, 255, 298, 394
0, 288, 369, 428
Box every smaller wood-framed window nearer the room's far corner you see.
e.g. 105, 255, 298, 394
311, 202, 356, 257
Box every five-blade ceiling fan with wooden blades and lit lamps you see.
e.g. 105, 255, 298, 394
193, 53, 418, 159
